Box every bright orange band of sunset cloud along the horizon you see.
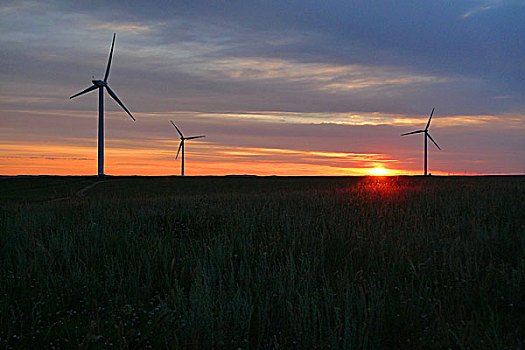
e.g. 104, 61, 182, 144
0, 142, 410, 175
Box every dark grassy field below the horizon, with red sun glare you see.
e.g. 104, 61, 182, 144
0, 177, 525, 349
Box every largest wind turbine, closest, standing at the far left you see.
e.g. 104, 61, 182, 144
70, 34, 135, 176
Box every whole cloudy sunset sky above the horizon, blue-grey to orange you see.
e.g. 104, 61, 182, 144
0, 0, 525, 175
